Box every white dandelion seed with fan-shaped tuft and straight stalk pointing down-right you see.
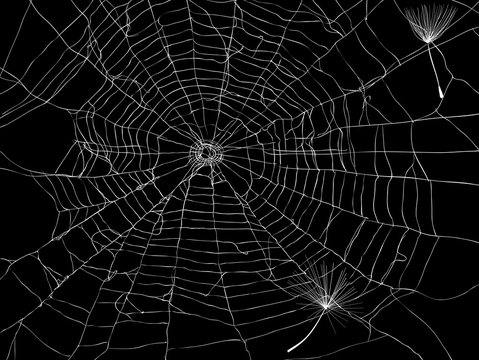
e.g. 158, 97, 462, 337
404, 4, 457, 99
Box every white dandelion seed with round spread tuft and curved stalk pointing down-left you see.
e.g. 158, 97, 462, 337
288, 263, 358, 352
